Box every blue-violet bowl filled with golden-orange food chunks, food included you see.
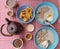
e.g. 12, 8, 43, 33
16, 5, 35, 23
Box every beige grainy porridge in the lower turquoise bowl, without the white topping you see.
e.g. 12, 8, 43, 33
36, 29, 54, 46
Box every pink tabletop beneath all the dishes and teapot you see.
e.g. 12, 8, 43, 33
0, 0, 60, 49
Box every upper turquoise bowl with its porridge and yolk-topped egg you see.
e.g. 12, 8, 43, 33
35, 2, 58, 25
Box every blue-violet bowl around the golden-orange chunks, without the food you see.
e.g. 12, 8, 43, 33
16, 5, 35, 23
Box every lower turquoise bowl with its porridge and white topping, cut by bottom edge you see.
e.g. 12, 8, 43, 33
34, 27, 59, 49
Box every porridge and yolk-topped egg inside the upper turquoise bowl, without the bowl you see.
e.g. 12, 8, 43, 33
37, 6, 54, 22
